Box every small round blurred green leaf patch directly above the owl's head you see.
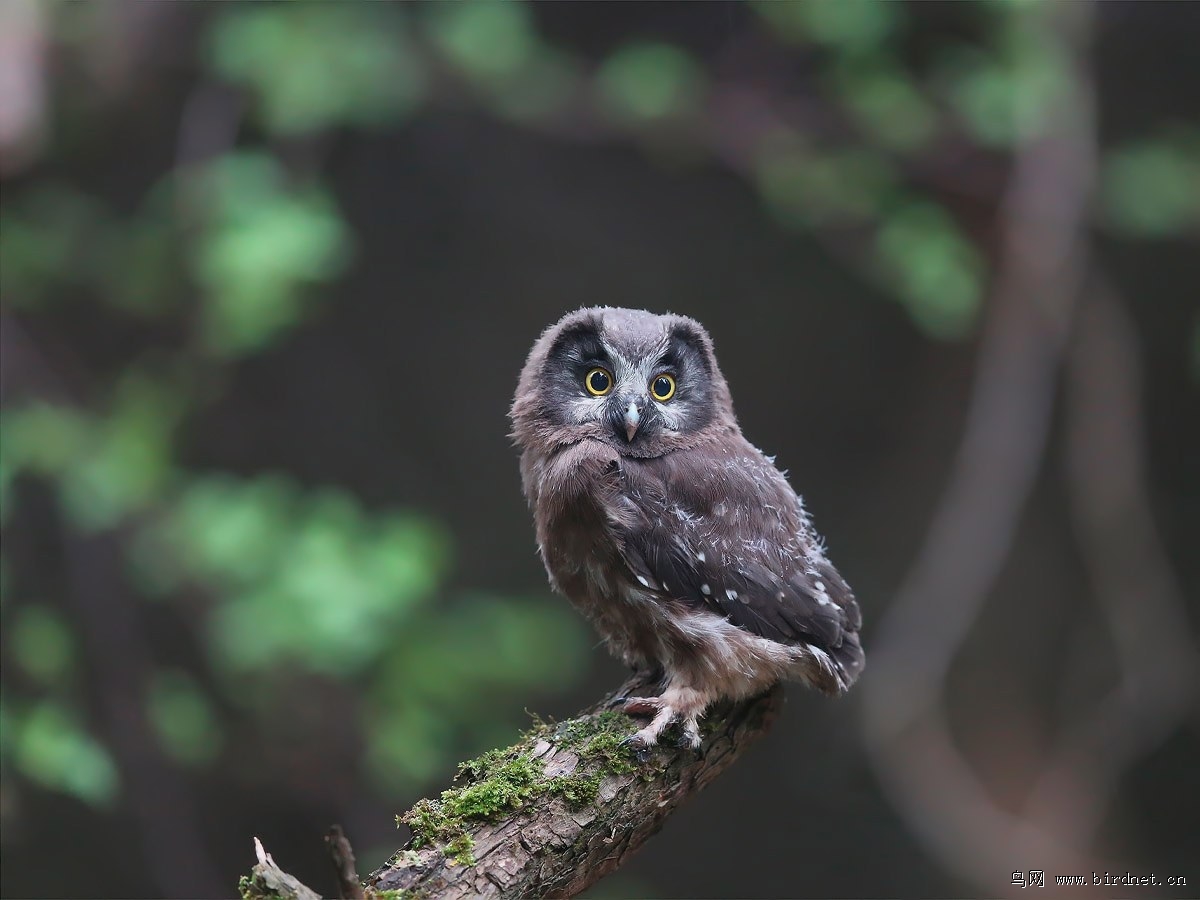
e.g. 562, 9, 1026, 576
595, 41, 704, 121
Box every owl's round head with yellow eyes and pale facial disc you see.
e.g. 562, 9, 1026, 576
510, 306, 737, 457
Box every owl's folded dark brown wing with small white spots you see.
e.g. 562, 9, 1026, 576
610, 438, 863, 690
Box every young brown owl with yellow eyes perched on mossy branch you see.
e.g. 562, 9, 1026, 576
510, 307, 864, 751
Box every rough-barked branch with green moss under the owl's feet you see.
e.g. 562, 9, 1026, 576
244, 682, 782, 900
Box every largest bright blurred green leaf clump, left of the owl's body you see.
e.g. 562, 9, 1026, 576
176, 479, 448, 677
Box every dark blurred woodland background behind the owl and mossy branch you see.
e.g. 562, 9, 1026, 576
0, 0, 1200, 898
